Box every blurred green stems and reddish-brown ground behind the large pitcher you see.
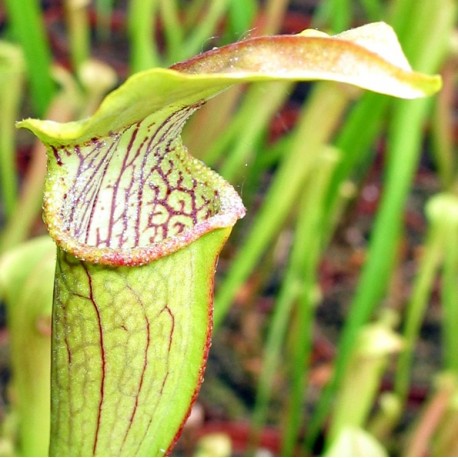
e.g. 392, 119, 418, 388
0, 0, 458, 455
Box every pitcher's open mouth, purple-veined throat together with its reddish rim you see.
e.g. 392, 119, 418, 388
44, 106, 245, 266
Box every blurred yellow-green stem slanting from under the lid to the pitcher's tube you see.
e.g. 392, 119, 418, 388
215, 83, 349, 328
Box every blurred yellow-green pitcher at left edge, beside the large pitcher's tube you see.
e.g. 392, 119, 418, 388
0, 236, 56, 456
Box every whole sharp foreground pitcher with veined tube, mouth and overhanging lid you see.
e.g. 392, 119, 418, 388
19, 24, 441, 455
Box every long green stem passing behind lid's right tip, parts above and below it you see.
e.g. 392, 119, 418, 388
308, 0, 455, 444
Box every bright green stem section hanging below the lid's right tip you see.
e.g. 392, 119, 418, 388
309, 95, 427, 448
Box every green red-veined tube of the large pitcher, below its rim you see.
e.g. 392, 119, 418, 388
51, 224, 228, 456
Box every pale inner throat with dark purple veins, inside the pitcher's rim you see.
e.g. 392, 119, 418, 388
53, 107, 219, 249
